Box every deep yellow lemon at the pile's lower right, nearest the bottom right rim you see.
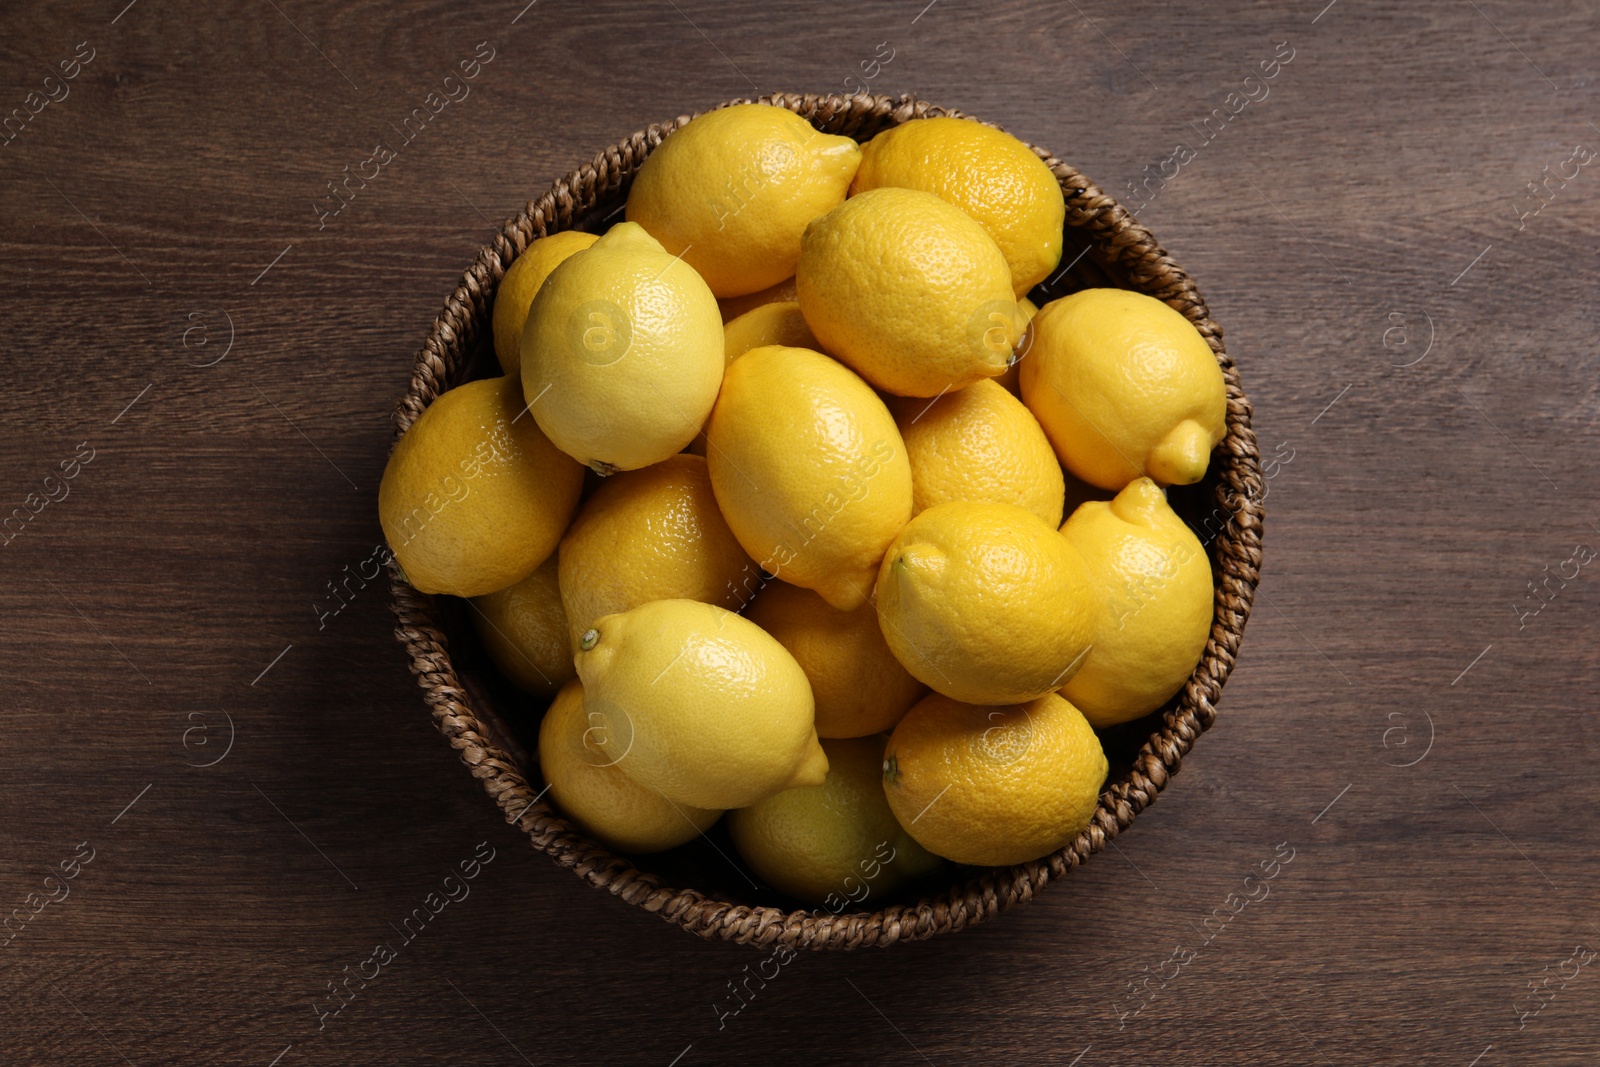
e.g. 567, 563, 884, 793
883, 693, 1109, 867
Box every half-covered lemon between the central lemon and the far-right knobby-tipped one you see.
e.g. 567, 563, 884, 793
891, 381, 1066, 526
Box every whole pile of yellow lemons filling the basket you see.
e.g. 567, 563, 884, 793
379, 104, 1226, 910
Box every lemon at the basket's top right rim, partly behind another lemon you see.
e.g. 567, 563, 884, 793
851, 115, 1067, 296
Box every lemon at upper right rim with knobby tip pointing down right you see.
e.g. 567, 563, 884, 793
1021, 290, 1227, 490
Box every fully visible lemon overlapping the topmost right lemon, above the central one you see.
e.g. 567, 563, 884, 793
795, 189, 1022, 397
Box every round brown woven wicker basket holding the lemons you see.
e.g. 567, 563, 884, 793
392, 94, 1262, 949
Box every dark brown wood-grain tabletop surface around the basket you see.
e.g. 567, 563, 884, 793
0, 0, 1600, 1067
